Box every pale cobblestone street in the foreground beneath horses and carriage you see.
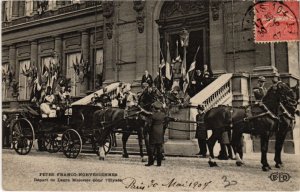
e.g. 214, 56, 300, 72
2, 149, 300, 191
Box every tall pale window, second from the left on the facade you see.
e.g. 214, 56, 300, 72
19, 59, 30, 100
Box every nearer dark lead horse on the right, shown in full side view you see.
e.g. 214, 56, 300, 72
204, 82, 291, 171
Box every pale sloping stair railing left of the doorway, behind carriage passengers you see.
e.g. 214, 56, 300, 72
72, 82, 120, 105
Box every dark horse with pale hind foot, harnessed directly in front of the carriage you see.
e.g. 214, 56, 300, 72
92, 106, 148, 160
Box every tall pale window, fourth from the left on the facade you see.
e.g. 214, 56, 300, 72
67, 52, 81, 96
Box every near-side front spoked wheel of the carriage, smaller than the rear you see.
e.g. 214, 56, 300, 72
62, 129, 82, 159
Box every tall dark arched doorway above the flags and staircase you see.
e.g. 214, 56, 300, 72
156, 1, 211, 73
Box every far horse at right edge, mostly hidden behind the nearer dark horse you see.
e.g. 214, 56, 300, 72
274, 82, 300, 168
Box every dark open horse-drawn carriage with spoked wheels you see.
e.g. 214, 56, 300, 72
3, 105, 112, 158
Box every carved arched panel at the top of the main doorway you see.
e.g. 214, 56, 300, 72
161, 0, 209, 19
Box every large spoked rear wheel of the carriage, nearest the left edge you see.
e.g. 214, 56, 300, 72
12, 118, 35, 155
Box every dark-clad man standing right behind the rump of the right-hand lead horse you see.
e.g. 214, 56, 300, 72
195, 105, 207, 158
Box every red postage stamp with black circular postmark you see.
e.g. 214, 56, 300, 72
254, 1, 300, 42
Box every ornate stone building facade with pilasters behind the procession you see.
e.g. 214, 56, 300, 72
2, 0, 300, 153
